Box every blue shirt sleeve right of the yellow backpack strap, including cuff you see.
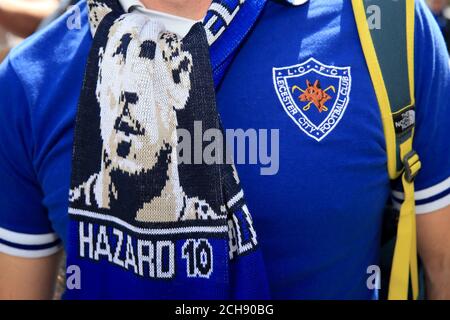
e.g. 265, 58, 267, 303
393, 0, 450, 214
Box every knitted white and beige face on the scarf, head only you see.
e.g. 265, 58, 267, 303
96, 16, 192, 174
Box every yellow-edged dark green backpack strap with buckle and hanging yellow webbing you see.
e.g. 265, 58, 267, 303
352, 0, 421, 300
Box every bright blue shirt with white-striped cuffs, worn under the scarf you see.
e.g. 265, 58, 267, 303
0, 0, 450, 299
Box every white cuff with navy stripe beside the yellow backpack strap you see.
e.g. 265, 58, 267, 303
392, 177, 450, 214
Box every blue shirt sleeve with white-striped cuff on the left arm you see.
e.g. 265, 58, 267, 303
0, 60, 61, 258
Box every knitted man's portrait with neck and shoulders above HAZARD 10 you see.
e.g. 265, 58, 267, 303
70, 14, 221, 223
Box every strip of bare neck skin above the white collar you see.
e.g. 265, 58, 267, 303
140, 0, 211, 20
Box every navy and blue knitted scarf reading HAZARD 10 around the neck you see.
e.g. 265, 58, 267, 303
65, 0, 268, 299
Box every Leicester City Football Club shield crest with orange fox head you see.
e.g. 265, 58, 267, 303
273, 58, 352, 141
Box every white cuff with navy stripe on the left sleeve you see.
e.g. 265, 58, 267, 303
0, 227, 62, 258
